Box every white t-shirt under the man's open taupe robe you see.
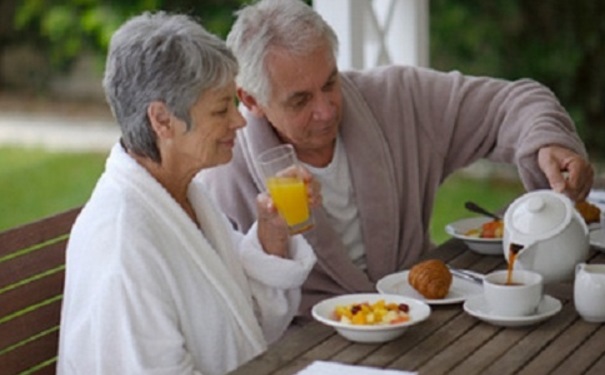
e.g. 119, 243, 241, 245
303, 137, 366, 270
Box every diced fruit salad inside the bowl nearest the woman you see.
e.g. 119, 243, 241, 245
334, 299, 410, 325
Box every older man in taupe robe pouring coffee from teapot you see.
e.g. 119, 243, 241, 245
200, 0, 593, 314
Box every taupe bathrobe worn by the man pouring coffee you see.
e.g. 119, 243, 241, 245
201, 66, 585, 314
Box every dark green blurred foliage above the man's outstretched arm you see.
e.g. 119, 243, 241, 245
430, 0, 605, 158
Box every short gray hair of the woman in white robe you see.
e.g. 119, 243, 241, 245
103, 12, 238, 162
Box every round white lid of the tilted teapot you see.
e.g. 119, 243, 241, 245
504, 190, 574, 240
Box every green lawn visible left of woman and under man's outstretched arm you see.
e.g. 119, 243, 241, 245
0, 148, 523, 244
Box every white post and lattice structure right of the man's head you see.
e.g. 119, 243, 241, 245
313, 0, 429, 70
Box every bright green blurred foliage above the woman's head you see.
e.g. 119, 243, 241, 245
15, 0, 244, 70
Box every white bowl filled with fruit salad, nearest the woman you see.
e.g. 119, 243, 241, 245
311, 293, 431, 343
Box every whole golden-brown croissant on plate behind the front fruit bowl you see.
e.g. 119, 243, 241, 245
408, 259, 452, 299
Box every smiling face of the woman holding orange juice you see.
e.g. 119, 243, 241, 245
171, 83, 245, 173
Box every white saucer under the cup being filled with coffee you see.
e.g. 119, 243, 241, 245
463, 295, 562, 327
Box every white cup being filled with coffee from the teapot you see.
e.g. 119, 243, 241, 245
483, 269, 543, 317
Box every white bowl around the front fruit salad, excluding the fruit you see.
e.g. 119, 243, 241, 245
311, 293, 431, 343
